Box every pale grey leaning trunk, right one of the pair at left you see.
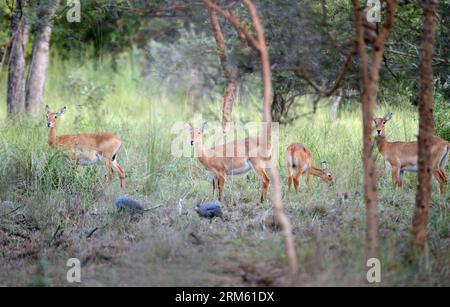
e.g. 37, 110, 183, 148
25, 0, 60, 116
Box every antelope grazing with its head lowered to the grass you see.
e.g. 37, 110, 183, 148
286, 143, 333, 193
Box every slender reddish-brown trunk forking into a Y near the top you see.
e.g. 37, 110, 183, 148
352, 0, 397, 258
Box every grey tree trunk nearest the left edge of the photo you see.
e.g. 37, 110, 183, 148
6, 0, 30, 116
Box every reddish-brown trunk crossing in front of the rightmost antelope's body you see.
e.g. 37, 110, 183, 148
413, 0, 438, 248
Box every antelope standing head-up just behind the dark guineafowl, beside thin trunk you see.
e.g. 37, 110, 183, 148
186, 124, 272, 202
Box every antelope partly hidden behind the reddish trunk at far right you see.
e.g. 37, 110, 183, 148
373, 113, 450, 194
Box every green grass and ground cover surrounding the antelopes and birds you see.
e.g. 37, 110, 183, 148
0, 56, 450, 286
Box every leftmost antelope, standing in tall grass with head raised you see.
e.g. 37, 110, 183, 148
45, 105, 125, 188
